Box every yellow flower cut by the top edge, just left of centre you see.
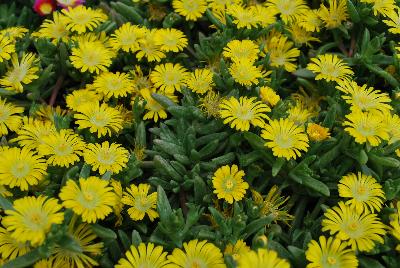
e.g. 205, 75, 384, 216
172, 0, 207, 21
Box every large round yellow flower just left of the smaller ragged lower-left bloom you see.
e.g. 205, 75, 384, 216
60, 177, 117, 223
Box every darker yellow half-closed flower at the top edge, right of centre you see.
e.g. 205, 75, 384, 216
318, 0, 349, 29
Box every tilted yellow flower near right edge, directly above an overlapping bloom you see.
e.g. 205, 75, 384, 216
336, 80, 393, 112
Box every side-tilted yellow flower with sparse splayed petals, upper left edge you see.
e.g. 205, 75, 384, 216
0, 53, 39, 93
